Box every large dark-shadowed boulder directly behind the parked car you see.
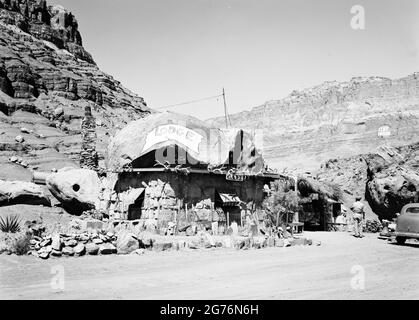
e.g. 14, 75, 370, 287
365, 144, 419, 220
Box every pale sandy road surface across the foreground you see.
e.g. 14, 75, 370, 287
0, 232, 419, 299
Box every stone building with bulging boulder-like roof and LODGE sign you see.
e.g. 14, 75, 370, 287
107, 112, 278, 228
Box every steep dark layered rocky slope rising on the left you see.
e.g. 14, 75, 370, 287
0, 0, 150, 180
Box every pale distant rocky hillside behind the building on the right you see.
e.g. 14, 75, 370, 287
209, 73, 419, 171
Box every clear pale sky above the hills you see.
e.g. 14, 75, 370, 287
56, 0, 419, 119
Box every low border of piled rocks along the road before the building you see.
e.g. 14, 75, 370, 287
26, 226, 320, 259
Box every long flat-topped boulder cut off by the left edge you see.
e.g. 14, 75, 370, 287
0, 180, 51, 206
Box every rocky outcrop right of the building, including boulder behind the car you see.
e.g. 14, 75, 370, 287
316, 143, 419, 220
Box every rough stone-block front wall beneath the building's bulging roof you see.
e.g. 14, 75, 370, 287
111, 172, 272, 229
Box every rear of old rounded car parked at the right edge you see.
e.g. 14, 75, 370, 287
394, 203, 419, 244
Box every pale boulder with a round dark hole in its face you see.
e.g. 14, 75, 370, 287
46, 168, 100, 215
